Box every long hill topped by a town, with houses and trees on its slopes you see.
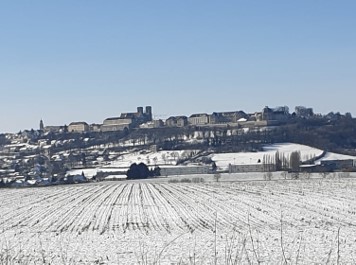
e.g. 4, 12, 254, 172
0, 106, 356, 185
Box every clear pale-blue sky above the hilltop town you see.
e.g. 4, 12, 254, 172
0, 0, 356, 132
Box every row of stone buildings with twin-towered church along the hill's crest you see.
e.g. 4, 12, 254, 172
40, 106, 314, 133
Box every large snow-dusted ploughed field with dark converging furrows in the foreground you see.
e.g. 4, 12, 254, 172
0, 177, 356, 264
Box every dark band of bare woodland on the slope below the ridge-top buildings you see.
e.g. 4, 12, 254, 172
127, 118, 356, 155
